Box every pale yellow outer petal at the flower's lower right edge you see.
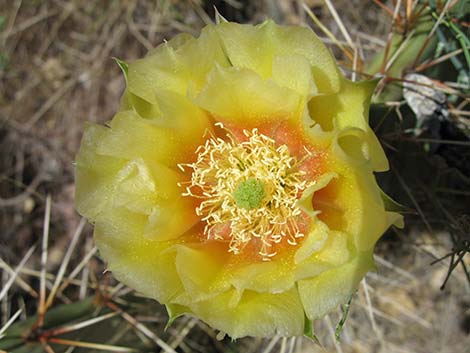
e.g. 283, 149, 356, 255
298, 252, 373, 320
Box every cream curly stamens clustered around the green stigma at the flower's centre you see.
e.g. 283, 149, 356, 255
179, 125, 311, 261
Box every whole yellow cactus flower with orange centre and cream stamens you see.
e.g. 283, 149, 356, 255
76, 21, 401, 338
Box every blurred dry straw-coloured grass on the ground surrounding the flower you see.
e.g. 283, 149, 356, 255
0, 0, 470, 353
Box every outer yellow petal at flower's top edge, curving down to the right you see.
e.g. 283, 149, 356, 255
216, 21, 340, 93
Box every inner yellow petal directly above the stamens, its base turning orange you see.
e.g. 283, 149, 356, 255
194, 66, 300, 128
